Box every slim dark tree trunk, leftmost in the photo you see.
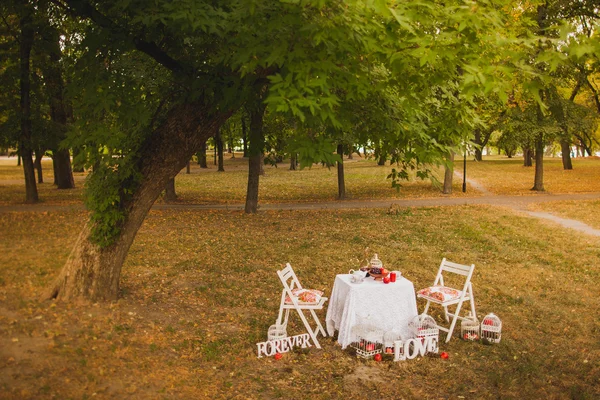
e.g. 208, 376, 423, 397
19, 7, 39, 203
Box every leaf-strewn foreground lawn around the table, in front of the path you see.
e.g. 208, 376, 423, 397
0, 204, 600, 399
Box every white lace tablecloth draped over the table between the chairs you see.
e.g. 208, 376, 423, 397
326, 274, 417, 349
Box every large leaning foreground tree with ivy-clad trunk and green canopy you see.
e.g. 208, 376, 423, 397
42, 0, 528, 301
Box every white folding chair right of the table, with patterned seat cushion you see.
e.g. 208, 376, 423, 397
417, 258, 477, 343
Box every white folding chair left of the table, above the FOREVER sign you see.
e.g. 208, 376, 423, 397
277, 263, 327, 349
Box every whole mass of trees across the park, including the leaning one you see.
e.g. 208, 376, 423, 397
0, 0, 600, 300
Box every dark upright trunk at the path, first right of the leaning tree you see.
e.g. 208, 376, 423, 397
245, 96, 265, 214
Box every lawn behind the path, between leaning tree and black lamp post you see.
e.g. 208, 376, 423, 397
175, 157, 475, 204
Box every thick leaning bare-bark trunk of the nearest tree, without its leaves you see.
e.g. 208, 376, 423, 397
44, 102, 230, 302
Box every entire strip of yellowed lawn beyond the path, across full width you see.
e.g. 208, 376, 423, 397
0, 154, 600, 205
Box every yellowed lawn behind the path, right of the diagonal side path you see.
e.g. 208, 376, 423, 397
464, 156, 600, 195
